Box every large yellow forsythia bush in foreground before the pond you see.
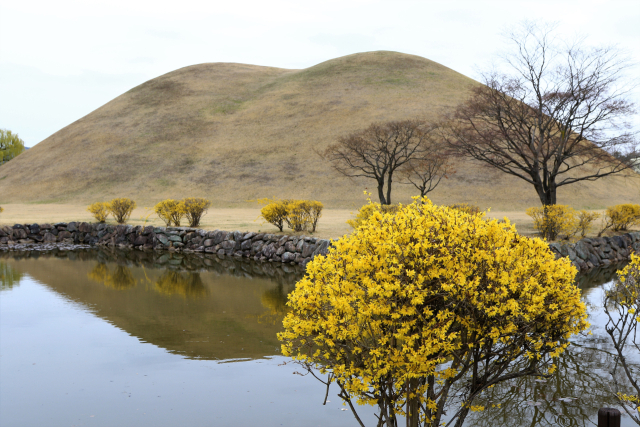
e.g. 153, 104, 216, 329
278, 198, 588, 426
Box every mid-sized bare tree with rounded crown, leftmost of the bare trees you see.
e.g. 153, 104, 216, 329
323, 120, 430, 205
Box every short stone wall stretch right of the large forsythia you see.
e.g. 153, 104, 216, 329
549, 231, 640, 271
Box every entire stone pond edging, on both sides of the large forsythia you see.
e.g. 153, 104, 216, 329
0, 222, 640, 272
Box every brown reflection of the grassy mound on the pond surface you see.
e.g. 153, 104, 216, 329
0, 249, 302, 360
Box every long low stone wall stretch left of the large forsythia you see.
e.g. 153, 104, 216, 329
0, 222, 331, 266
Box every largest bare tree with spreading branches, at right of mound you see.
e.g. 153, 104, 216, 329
443, 23, 638, 206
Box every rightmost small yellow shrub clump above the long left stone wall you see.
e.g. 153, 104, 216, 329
260, 199, 324, 233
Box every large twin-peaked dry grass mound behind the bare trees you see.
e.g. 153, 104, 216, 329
0, 52, 640, 209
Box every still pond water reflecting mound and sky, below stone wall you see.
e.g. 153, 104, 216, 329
0, 249, 637, 427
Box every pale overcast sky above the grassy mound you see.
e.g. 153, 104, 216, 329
0, 0, 640, 146
